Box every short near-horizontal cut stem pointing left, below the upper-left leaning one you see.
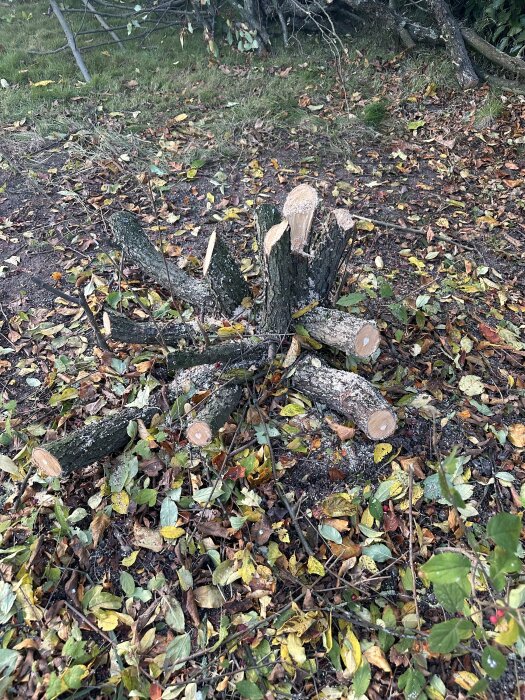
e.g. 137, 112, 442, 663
104, 307, 199, 346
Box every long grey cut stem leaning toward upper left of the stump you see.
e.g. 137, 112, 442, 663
110, 211, 210, 308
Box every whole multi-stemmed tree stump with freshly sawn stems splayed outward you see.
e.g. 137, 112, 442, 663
33, 184, 396, 476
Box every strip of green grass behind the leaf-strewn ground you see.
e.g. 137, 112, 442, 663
0, 0, 460, 160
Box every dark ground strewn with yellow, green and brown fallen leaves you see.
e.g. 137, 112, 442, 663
0, 32, 525, 700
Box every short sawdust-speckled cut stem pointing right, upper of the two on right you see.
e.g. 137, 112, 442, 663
298, 306, 380, 357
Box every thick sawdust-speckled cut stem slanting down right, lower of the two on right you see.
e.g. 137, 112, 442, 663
291, 354, 397, 440
